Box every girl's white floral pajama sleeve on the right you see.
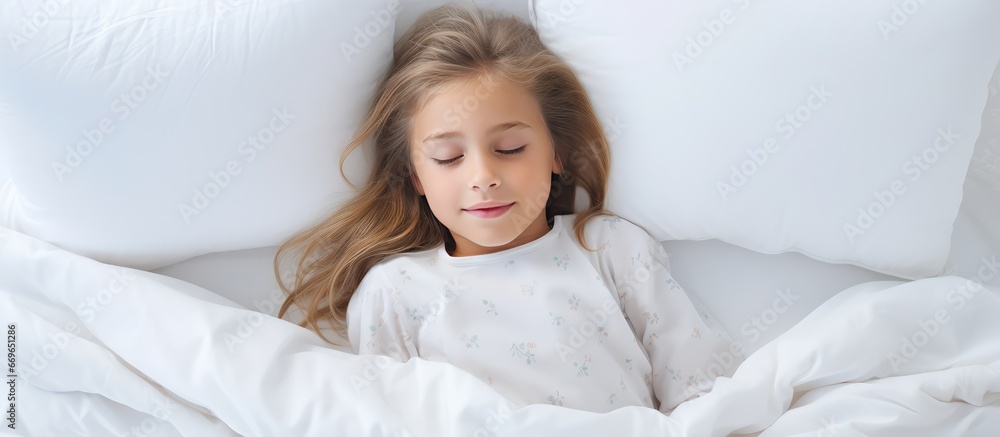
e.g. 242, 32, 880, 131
608, 222, 743, 414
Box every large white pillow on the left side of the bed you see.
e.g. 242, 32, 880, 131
0, 0, 401, 269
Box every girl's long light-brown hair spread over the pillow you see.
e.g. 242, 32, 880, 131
274, 4, 611, 343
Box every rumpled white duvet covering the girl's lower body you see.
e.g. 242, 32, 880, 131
0, 228, 1000, 436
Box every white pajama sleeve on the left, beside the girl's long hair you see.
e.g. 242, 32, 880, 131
347, 265, 418, 362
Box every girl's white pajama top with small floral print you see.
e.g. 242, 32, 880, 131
348, 214, 743, 413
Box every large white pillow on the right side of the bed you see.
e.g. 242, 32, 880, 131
531, 0, 1000, 279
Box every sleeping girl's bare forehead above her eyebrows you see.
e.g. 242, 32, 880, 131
410, 79, 542, 144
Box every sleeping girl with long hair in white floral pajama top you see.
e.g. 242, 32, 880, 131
275, 5, 740, 414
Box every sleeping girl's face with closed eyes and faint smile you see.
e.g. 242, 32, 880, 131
410, 79, 562, 256
